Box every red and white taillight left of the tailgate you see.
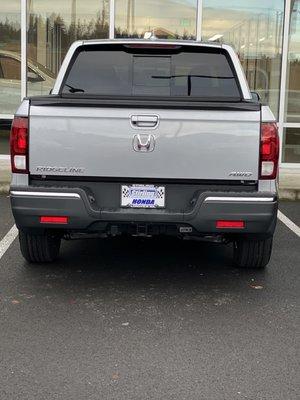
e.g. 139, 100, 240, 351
10, 117, 28, 174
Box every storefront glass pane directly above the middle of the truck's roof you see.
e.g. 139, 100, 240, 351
115, 0, 197, 39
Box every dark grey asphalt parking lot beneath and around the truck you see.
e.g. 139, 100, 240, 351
0, 196, 300, 400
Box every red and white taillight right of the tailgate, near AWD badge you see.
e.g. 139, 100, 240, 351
260, 122, 279, 179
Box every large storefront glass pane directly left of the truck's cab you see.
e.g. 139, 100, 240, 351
27, 0, 109, 95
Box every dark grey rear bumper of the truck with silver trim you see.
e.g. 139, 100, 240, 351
11, 186, 277, 236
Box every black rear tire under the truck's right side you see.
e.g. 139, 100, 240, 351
233, 237, 273, 268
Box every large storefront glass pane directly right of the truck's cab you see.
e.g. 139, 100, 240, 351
202, 0, 284, 117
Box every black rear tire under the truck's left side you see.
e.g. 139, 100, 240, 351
19, 230, 61, 263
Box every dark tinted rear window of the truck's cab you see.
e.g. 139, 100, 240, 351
61, 44, 241, 101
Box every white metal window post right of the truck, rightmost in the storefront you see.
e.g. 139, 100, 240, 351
278, 0, 291, 165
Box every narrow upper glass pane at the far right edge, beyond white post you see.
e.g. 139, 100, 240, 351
286, 0, 300, 123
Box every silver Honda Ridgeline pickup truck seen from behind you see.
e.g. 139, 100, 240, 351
10, 40, 279, 268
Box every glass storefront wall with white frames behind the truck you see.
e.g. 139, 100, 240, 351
0, 0, 300, 166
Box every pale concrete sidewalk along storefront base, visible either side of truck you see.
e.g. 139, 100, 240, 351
0, 158, 300, 200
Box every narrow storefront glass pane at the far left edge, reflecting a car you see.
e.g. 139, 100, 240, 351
0, 0, 21, 118
